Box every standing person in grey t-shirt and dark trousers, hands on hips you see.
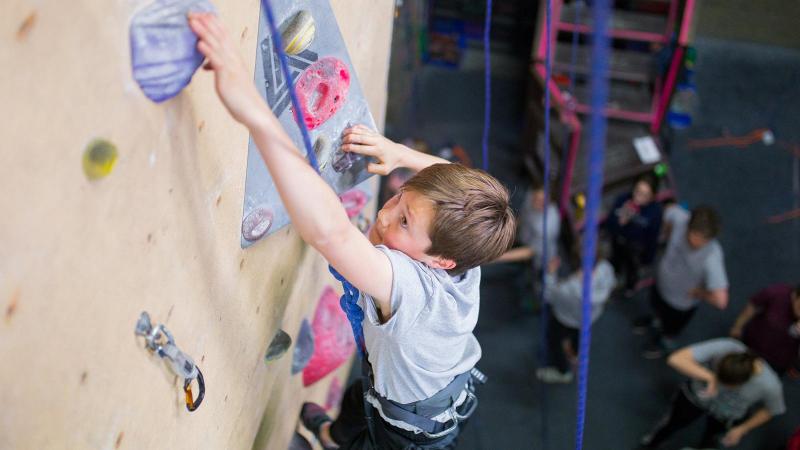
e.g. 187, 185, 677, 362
635, 205, 728, 358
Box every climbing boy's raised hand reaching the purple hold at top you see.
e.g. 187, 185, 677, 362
188, 13, 269, 128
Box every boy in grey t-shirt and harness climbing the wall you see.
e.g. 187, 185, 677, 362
189, 14, 515, 449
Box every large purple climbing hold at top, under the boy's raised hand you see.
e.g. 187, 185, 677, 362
130, 0, 216, 102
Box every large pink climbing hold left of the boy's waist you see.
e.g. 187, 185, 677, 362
303, 286, 356, 386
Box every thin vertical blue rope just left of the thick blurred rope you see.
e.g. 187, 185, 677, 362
539, 0, 553, 450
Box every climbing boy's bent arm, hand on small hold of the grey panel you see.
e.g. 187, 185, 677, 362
342, 125, 450, 175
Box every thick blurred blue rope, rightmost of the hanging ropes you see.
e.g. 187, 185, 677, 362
575, 0, 611, 450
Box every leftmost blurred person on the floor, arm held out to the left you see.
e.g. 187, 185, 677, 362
495, 181, 561, 310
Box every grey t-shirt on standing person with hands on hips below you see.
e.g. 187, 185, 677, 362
657, 206, 728, 311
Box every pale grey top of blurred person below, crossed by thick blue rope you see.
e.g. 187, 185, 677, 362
544, 260, 615, 328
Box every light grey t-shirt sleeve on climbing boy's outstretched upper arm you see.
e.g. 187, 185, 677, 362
364, 245, 431, 334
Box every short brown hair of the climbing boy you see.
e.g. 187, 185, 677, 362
403, 164, 516, 274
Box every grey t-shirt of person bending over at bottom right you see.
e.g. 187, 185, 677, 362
689, 338, 786, 422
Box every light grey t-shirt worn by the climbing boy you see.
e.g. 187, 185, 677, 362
359, 245, 481, 403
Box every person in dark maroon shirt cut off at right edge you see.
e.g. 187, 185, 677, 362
731, 284, 800, 375
